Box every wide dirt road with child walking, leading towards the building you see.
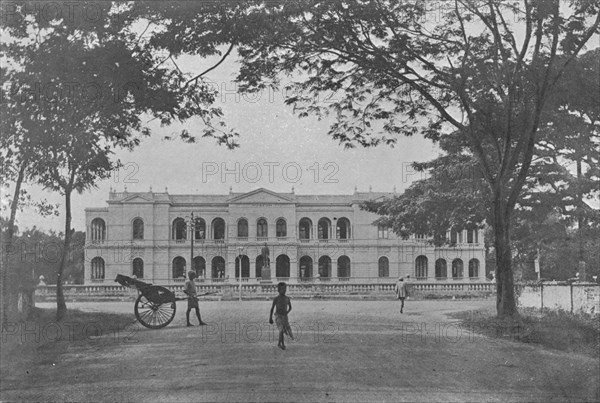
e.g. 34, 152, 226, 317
1, 300, 600, 402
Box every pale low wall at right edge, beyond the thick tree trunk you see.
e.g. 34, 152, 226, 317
517, 283, 600, 314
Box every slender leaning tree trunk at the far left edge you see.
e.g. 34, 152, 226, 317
1, 160, 27, 324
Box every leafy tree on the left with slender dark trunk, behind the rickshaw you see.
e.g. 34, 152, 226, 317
2, 2, 236, 320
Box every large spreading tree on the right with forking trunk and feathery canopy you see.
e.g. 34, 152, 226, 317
225, 0, 600, 316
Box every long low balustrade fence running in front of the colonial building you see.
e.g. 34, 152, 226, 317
35, 281, 496, 301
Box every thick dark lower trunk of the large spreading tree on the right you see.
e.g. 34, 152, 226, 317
494, 200, 517, 317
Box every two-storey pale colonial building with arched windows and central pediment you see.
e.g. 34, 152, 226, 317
85, 188, 485, 284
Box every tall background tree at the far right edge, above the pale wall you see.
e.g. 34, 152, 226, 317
536, 49, 600, 279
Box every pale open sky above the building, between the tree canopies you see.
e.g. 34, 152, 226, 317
2, 54, 438, 232
